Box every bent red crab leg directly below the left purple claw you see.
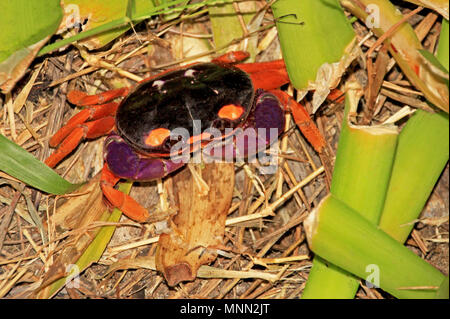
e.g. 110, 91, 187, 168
100, 164, 150, 223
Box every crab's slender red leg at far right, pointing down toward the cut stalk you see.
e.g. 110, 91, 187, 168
270, 90, 325, 153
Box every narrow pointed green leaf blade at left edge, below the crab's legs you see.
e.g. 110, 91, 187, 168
0, 134, 81, 195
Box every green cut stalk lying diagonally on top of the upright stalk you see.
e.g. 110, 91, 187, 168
304, 194, 446, 299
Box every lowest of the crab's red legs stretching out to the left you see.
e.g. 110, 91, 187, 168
45, 116, 115, 167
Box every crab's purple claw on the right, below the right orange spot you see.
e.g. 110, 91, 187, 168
203, 90, 285, 161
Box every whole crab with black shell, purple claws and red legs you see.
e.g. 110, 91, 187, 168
45, 51, 325, 222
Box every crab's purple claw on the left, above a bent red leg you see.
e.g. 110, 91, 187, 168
105, 133, 185, 181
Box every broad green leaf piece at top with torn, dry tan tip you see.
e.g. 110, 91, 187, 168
272, 0, 358, 112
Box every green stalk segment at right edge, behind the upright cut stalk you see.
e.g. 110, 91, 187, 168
380, 110, 449, 243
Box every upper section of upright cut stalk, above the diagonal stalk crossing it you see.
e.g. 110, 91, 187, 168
330, 123, 398, 225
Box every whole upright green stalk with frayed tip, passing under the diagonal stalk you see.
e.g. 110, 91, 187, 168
302, 84, 398, 299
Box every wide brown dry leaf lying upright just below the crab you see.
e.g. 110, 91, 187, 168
156, 163, 234, 286
